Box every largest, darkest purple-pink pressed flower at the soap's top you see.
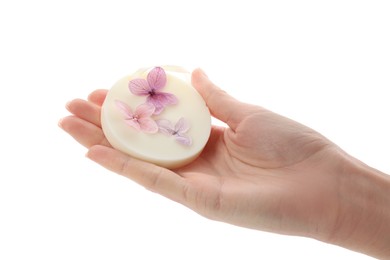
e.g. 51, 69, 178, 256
129, 67, 178, 115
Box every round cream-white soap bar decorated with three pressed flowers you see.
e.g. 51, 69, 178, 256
101, 66, 211, 168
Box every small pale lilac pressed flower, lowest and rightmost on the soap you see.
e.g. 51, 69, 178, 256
157, 118, 192, 146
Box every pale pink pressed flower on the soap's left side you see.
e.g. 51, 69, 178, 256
115, 100, 158, 134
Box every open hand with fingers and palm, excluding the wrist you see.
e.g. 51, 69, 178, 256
60, 70, 342, 242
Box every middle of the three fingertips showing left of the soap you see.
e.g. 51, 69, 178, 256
66, 99, 101, 127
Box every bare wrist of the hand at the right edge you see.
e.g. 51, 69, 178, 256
326, 155, 390, 258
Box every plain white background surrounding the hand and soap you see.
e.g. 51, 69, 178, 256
0, 0, 390, 259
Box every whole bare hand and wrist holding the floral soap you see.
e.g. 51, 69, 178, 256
59, 69, 390, 259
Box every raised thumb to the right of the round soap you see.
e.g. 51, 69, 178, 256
192, 69, 245, 130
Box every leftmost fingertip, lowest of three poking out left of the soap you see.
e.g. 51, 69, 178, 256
58, 116, 111, 148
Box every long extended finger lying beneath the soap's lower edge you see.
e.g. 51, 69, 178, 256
86, 145, 187, 203
